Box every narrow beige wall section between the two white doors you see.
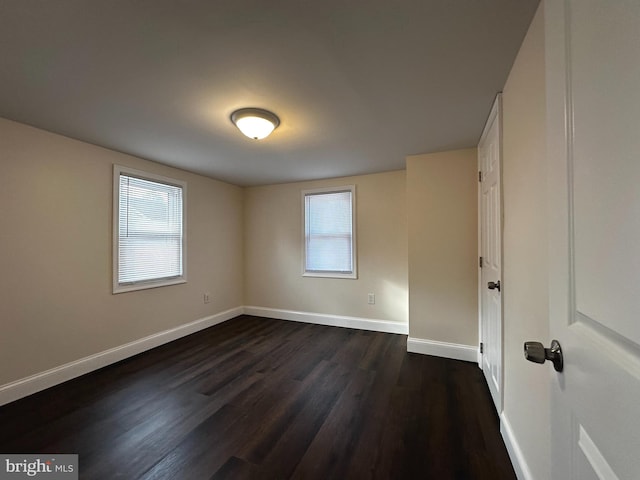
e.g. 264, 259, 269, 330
503, 4, 551, 480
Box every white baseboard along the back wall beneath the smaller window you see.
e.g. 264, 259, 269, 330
244, 306, 409, 335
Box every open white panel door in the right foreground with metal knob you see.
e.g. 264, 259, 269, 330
545, 0, 640, 480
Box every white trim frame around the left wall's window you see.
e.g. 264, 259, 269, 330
111, 164, 187, 294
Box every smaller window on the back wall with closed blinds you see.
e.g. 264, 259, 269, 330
302, 185, 357, 278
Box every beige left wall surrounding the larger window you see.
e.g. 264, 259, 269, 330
0, 119, 243, 385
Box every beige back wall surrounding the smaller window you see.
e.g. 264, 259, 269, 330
245, 171, 407, 323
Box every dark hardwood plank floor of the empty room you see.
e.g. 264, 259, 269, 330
0, 316, 515, 480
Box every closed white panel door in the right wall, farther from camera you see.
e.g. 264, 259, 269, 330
478, 95, 502, 412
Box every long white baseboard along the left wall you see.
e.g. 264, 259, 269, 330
0, 307, 243, 406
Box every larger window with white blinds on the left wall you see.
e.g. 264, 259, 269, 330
113, 165, 187, 293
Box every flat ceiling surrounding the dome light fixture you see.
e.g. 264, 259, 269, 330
0, 0, 538, 185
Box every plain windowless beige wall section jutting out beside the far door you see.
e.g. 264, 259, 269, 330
407, 148, 478, 346
